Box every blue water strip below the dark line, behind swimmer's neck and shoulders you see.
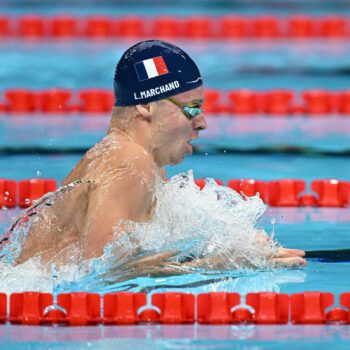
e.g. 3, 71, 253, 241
0, 152, 350, 183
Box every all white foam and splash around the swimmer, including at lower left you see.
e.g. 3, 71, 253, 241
0, 171, 282, 292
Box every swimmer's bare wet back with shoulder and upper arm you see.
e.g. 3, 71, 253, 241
20, 136, 156, 262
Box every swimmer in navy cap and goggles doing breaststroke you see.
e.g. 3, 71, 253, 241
6, 40, 306, 267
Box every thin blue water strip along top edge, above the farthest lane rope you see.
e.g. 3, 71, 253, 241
0, 0, 350, 16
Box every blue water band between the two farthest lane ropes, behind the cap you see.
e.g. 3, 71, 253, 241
0, 39, 350, 91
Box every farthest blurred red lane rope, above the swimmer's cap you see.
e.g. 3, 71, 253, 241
0, 14, 350, 40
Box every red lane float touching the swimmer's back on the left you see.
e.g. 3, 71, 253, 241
18, 179, 57, 208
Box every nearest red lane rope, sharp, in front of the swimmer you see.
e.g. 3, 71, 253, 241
0, 291, 350, 326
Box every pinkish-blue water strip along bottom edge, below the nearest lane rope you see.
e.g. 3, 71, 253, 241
0, 325, 350, 350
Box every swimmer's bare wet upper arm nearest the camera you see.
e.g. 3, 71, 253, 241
83, 148, 156, 258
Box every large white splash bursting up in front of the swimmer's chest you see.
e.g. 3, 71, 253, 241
117, 171, 276, 269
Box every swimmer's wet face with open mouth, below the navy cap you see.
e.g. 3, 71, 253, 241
152, 86, 207, 166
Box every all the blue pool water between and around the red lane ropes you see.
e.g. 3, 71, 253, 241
0, 0, 350, 350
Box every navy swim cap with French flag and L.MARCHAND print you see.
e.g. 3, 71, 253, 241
114, 40, 203, 106
